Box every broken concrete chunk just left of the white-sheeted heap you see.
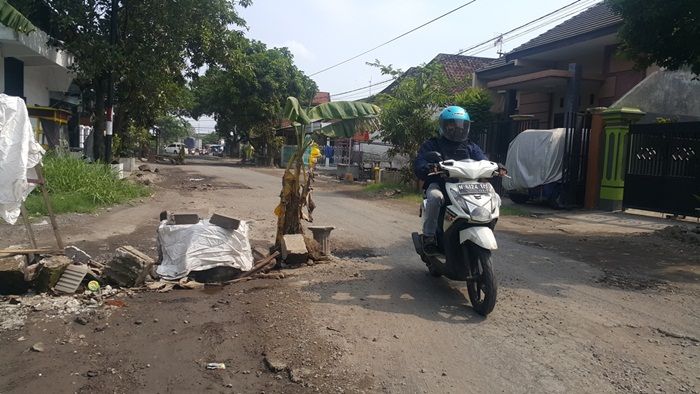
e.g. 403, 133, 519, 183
103, 246, 153, 287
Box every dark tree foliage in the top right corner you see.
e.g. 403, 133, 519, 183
606, 0, 700, 75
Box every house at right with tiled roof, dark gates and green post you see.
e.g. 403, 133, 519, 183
474, 3, 700, 216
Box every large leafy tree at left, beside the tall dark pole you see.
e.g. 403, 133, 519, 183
17, 0, 250, 157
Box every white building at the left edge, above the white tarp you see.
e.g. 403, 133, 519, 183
0, 3, 79, 146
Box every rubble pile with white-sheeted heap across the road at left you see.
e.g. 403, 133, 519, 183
0, 211, 328, 331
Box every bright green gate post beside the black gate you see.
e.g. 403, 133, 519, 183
600, 107, 645, 211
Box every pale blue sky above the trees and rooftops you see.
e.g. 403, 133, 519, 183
187, 0, 597, 132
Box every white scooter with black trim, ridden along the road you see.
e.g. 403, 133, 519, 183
412, 152, 501, 316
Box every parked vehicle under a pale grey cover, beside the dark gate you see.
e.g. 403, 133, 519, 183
503, 128, 565, 208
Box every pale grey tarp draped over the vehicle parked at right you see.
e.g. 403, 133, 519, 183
503, 129, 565, 190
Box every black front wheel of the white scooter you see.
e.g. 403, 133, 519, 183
462, 242, 498, 316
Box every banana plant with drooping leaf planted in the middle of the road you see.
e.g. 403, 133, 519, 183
275, 97, 380, 246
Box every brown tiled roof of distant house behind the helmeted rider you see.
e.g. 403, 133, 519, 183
380, 53, 495, 94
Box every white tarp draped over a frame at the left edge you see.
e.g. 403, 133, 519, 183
0, 94, 44, 224
